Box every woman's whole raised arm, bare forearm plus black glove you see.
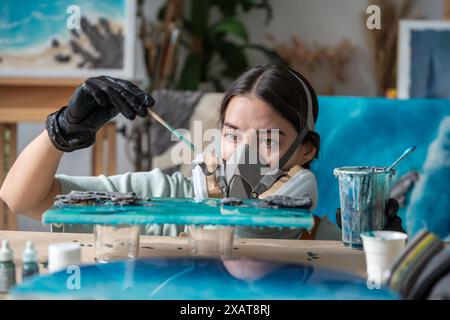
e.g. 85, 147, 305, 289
0, 76, 155, 220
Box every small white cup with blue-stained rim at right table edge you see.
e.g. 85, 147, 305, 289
361, 231, 408, 283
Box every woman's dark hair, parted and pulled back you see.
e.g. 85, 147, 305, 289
219, 64, 320, 168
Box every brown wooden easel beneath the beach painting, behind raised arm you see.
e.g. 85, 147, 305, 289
0, 78, 116, 230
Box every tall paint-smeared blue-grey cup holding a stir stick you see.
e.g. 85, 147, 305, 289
334, 167, 393, 249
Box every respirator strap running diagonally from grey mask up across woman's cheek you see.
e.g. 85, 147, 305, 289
251, 126, 309, 199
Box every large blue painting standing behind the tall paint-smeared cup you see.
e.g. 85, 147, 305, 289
312, 97, 450, 238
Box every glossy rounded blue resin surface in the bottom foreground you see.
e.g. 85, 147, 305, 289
13, 258, 396, 300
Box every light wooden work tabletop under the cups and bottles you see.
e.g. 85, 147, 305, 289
0, 231, 366, 299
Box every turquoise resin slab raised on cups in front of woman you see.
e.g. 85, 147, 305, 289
42, 198, 314, 230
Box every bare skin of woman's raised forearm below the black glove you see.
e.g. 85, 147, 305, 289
0, 130, 64, 220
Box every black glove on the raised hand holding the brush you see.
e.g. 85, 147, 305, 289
45, 76, 155, 152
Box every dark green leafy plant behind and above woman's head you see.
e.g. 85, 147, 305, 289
177, 0, 277, 91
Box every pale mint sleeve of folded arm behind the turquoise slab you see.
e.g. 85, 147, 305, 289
55, 169, 193, 236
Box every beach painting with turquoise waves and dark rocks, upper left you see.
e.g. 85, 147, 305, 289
0, 0, 136, 79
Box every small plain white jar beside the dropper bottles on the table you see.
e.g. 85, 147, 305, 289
48, 243, 81, 272
